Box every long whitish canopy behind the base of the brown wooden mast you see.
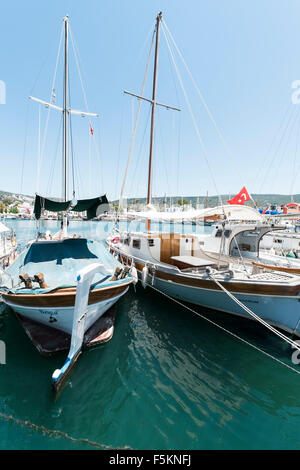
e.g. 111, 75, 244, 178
130, 204, 263, 221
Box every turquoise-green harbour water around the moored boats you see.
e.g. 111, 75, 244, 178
0, 221, 300, 449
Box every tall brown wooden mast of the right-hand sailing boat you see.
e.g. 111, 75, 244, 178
147, 12, 162, 231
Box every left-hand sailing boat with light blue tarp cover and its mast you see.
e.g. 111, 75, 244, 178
1, 16, 132, 388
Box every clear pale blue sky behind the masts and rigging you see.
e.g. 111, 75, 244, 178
0, 0, 300, 199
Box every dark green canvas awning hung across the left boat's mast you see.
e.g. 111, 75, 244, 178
33, 194, 109, 220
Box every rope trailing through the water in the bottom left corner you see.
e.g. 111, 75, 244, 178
0, 412, 130, 450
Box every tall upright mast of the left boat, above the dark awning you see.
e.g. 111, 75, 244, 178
62, 15, 69, 201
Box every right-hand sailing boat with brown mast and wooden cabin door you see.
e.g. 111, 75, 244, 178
107, 13, 300, 336
